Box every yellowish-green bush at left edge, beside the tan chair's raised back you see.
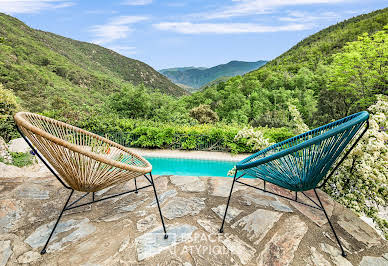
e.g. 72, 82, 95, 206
0, 84, 20, 142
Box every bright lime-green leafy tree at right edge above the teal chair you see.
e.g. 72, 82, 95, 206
328, 25, 388, 116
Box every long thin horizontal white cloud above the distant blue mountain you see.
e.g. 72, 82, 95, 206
154, 22, 312, 34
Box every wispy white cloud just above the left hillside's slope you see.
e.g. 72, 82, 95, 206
90, 16, 148, 44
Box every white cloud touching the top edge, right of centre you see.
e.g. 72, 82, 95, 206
193, 0, 351, 19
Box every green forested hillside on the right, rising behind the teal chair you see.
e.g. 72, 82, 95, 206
190, 8, 388, 127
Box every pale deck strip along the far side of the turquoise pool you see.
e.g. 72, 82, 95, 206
131, 148, 251, 162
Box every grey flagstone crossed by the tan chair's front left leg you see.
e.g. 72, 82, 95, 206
24, 218, 96, 252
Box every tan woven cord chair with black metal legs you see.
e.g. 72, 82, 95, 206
14, 112, 168, 254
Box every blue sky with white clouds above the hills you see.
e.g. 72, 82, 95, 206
0, 0, 388, 69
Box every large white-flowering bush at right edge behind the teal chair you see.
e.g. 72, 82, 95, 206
325, 95, 388, 239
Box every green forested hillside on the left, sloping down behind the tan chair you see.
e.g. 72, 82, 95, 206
0, 13, 187, 114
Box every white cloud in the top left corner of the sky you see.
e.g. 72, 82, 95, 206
0, 0, 74, 14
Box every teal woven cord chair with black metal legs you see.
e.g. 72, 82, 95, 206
220, 112, 369, 257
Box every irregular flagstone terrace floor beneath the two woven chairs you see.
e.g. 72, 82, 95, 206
0, 163, 388, 266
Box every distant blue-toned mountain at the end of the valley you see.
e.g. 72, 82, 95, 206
159, 60, 267, 91
